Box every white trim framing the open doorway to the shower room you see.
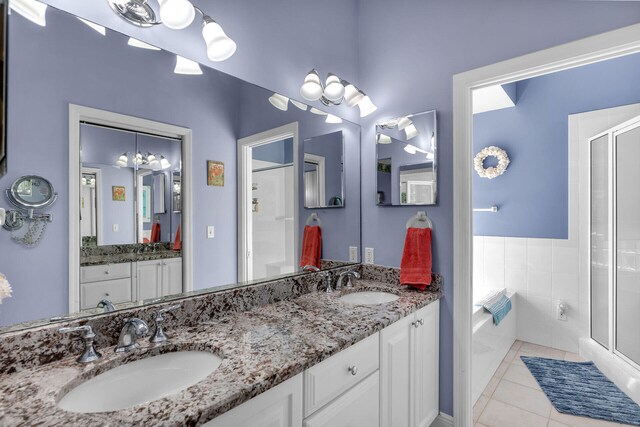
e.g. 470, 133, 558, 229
453, 24, 640, 427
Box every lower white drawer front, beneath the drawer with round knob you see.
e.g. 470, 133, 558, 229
303, 371, 380, 427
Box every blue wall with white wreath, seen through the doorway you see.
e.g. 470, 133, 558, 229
473, 54, 640, 239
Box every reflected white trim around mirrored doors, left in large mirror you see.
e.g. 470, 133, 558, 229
69, 104, 193, 313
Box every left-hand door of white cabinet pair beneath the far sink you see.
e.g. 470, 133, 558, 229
380, 315, 415, 427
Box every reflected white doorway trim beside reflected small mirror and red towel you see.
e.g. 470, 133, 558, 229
238, 122, 300, 282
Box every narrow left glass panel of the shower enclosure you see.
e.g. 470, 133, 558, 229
591, 135, 610, 349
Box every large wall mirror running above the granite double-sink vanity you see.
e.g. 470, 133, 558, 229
0, 2, 361, 331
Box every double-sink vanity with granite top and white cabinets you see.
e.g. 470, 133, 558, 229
0, 265, 441, 427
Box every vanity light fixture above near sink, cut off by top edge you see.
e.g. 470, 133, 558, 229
106, 0, 237, 62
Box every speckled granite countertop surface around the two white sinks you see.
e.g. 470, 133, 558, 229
0, 280, 441, 426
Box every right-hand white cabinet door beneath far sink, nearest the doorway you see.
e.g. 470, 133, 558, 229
411, 301, 440, 427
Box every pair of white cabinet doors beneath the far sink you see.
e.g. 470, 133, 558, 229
380, 301, 440, 427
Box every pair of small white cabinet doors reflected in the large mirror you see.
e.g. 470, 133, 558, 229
136, 257, 182, 300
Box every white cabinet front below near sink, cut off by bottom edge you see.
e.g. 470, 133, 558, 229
204, 374, 302, 427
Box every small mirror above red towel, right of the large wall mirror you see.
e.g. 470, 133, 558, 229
376, 110, 438, 206
